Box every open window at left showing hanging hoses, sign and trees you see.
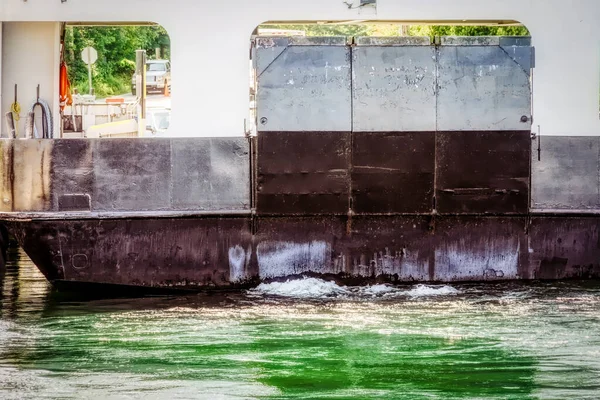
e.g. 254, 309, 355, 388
1, 22, 172, 138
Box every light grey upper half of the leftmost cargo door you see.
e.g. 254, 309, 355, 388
257, 45, 352, 132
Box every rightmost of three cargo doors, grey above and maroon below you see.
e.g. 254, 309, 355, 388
436, 37, 532, 214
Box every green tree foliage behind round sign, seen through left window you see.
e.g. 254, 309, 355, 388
64, 26, 170, 96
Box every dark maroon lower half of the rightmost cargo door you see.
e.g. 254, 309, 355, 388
436, 131, 531, 214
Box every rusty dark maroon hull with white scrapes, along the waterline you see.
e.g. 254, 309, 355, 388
7, 215, 600, 290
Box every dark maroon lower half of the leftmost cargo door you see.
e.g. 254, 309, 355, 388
257, 132, 350, 215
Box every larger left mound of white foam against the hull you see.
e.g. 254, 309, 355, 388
251, 277, 348, 298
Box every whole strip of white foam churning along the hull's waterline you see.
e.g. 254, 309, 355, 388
249, 277, 460, 299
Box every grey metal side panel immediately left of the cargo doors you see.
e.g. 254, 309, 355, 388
171, 138, 250, 210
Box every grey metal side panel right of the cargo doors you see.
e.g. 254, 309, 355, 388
531, 136, 600, 209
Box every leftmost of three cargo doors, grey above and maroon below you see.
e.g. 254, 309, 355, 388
255, 37, 352, 215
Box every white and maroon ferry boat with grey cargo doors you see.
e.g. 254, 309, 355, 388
0, 0, 600, 291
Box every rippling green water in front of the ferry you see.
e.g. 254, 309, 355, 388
0, 242, 600, 399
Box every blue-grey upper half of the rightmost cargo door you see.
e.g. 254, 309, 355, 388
437, 46, 531, 131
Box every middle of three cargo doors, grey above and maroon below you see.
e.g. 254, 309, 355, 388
352, 37, 436, 214
